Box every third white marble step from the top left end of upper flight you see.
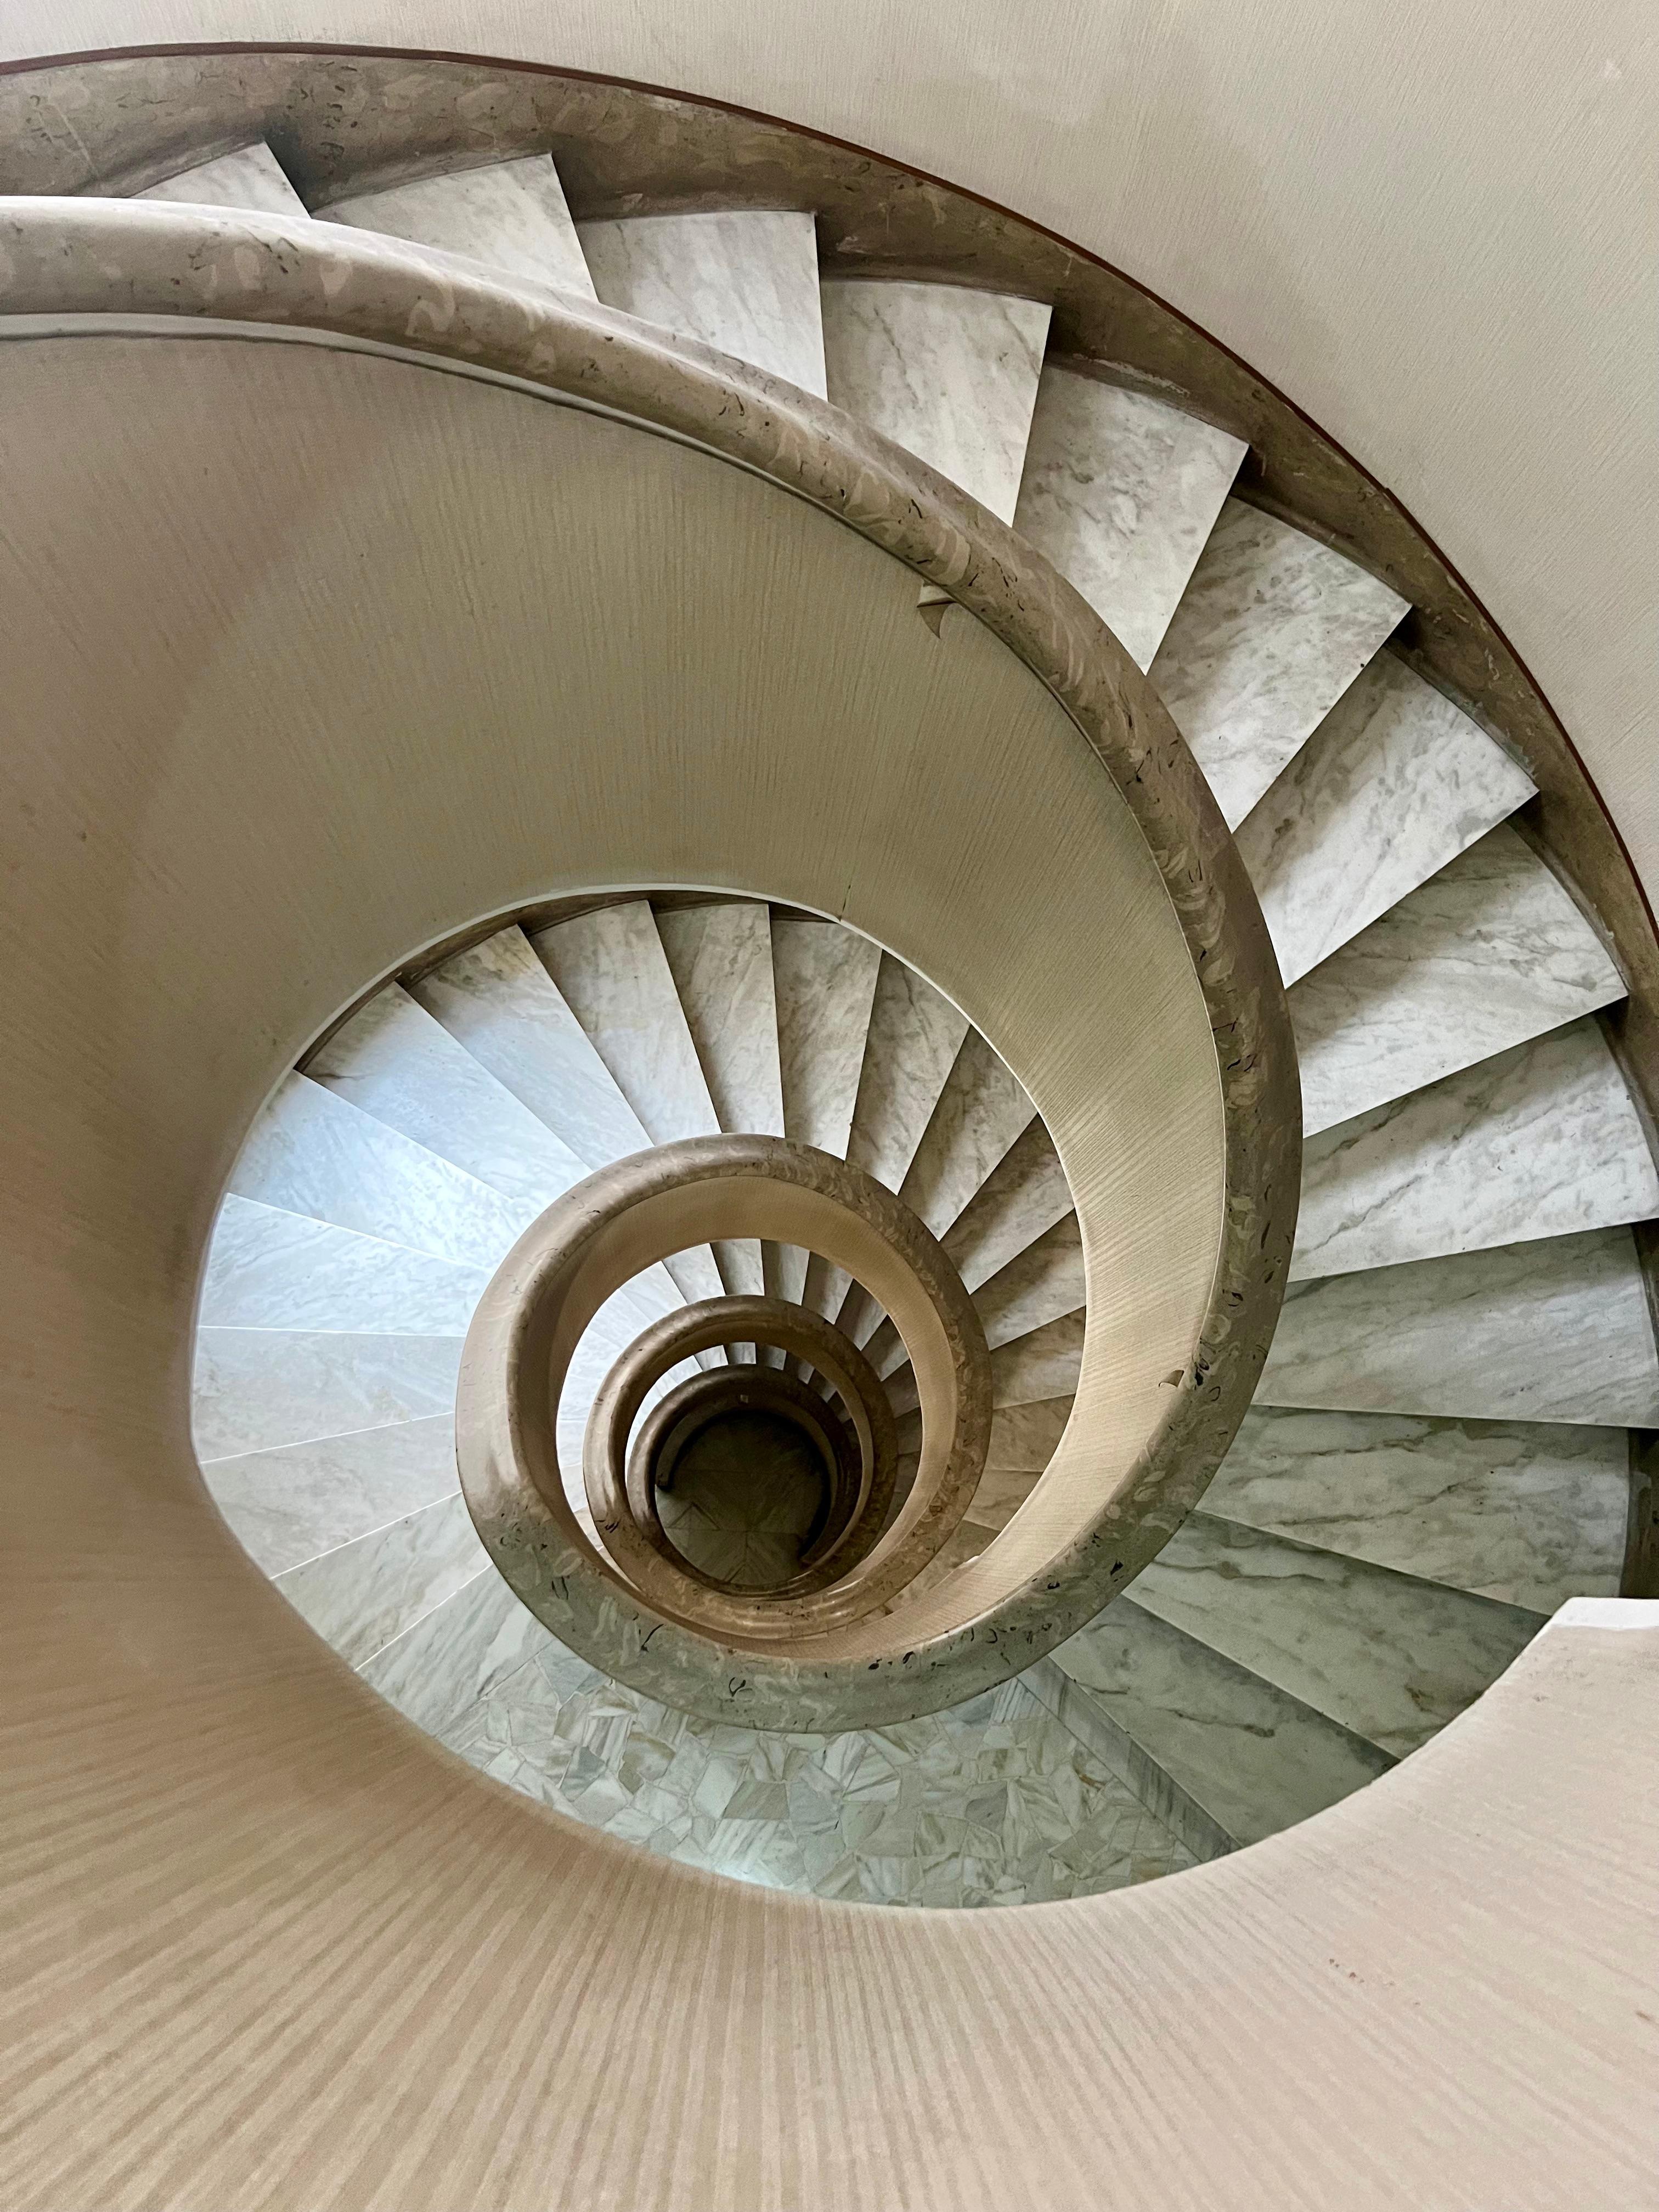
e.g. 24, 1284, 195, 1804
577, 208, 825, 398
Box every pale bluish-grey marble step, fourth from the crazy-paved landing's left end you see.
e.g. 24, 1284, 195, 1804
190, 1329, 462, 1466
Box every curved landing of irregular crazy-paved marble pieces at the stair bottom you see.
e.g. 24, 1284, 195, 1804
436, 1639, 1192, 1907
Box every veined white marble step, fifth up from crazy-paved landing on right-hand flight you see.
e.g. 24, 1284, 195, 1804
1290, 1020, 1659, 1278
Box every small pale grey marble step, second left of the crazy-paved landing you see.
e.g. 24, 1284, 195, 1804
276, 1493, 493, 1666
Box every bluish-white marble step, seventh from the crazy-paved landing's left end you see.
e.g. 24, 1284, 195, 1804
305, 984, 589, 1219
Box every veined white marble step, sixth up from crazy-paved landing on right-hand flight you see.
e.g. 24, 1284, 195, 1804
1290, 823, 1623, 1135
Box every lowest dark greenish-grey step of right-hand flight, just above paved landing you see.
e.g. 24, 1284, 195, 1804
1053, 1595, 1393, 1845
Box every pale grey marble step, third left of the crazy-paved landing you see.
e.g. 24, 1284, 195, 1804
204, 1413, 458, 1575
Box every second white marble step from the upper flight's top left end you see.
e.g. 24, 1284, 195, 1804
317, 153, 593, 298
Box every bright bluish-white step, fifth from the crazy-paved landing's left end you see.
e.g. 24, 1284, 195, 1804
199, 1194, 489, 1336
